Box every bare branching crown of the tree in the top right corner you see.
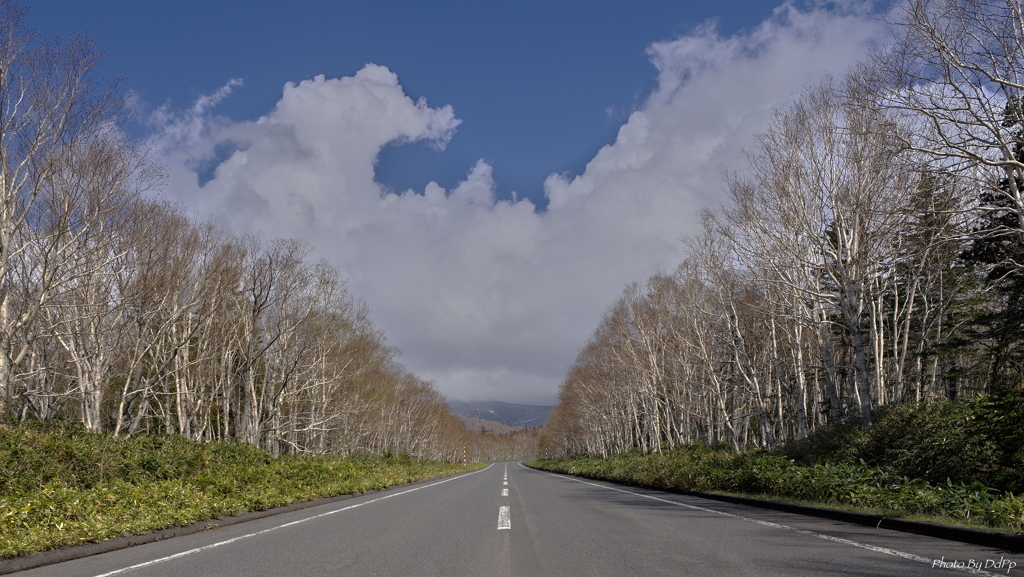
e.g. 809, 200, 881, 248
871, 0, 1024, 239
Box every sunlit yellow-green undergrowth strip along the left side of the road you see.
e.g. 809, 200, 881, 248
0, 422, 482, 559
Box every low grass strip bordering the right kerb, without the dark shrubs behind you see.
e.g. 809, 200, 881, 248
528, 445, 1024, 532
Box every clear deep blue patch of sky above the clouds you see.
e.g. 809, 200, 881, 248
27, 0, 775, 205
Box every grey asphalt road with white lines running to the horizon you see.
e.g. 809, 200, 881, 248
9, 463, 1024, 577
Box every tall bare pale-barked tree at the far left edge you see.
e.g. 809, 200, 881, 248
0, 1, 153, 415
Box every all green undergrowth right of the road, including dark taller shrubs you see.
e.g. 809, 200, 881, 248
528, 391, 1024, 532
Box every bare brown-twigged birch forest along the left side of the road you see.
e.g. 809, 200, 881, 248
0, 2, 487, 461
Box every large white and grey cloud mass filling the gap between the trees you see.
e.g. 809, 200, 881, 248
151, 4, 879, 404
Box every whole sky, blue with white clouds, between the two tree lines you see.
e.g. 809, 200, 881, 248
27, 0, 882, 404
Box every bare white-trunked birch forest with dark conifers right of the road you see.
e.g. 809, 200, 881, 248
541, 0, 1024, 457
